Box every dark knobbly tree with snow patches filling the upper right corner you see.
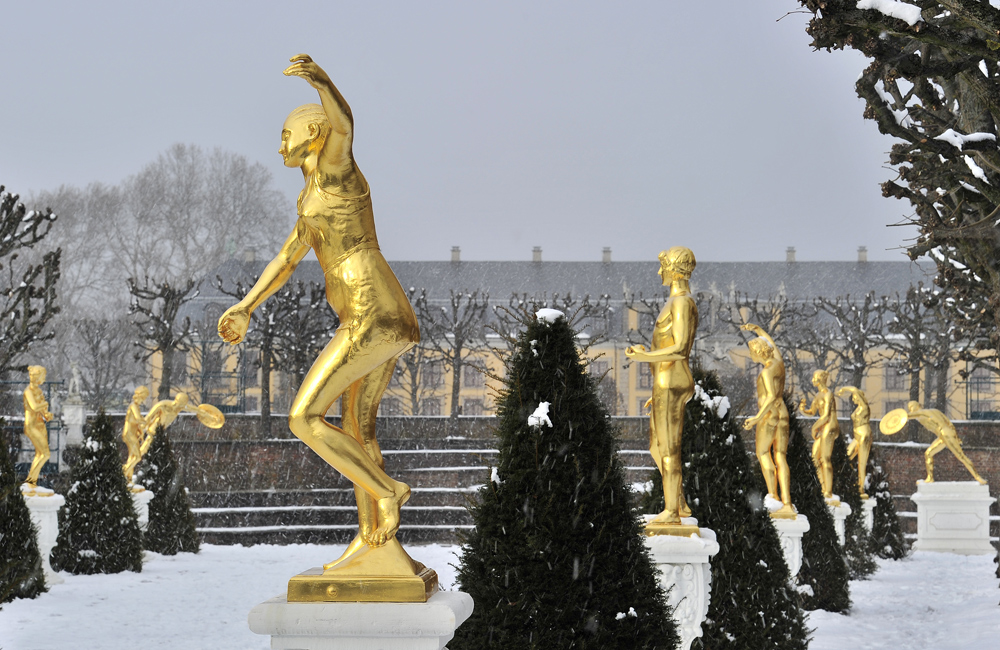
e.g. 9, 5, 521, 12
800, 0, 1000, 373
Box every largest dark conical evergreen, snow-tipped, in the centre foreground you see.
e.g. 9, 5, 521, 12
456, 318, 677, 650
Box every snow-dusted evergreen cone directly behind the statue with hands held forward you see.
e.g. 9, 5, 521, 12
680, 368, 808, 650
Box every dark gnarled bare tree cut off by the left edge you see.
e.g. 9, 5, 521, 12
0, 185, 62, 372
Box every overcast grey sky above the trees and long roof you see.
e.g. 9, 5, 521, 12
0, 0, 913, 261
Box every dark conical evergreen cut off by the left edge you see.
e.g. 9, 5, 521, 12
0, 420, 47, 603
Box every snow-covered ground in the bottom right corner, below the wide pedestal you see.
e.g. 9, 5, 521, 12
808, 551, 1000, 650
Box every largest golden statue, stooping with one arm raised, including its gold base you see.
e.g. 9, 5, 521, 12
219, 54, 437, 601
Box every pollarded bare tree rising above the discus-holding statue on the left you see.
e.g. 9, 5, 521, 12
128, 277, 198, 400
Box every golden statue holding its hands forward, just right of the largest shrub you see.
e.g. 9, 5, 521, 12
625, 246, 698, 537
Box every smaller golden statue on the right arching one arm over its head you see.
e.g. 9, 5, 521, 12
740, 323, 798, 519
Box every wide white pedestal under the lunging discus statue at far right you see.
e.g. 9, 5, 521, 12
910, 481, 996, 555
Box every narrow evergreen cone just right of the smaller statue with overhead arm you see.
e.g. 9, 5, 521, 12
785, 395, 851, 612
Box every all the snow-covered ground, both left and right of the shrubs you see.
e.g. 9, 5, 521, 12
0, 545, 1000, 650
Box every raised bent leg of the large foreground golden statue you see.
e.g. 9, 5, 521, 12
288, 328, 412, 546
